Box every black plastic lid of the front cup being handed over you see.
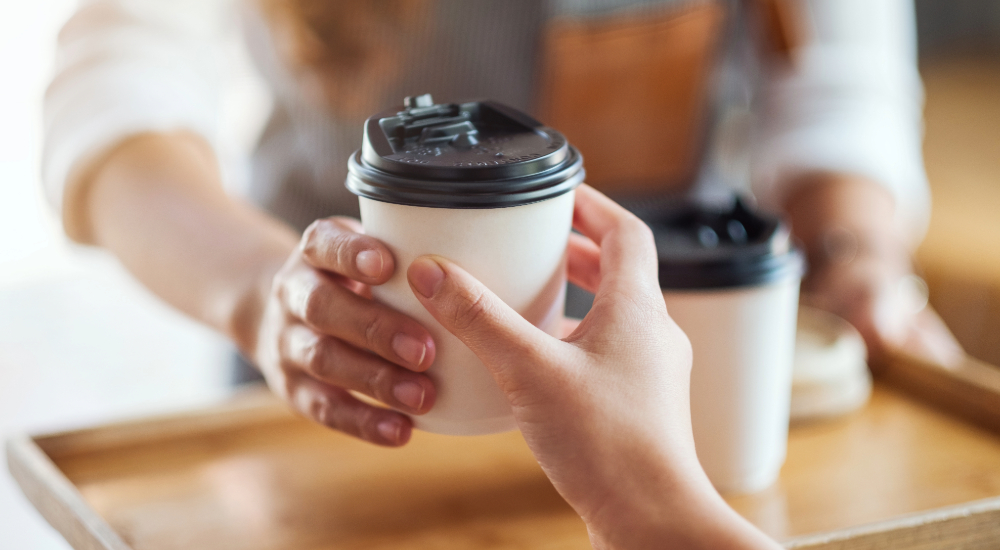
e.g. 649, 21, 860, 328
347, 94, 584, 208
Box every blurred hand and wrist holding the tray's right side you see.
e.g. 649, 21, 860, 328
785, 173, 963, 366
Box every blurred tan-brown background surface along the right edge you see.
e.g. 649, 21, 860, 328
918, 58, 1000, 365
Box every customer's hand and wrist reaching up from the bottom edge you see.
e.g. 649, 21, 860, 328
407, 186, 775, 548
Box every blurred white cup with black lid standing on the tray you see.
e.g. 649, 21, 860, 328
650, 201, 802, 493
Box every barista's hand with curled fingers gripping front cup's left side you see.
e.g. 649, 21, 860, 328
254, 218, 435, 446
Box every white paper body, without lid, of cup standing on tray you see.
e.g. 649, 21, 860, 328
663, 276, 799, 493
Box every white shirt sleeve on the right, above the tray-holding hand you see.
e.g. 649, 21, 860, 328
752, 0, 930, 239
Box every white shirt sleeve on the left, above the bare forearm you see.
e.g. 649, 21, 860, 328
42, 0, 236, 220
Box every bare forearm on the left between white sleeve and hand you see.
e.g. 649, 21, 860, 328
79, 133, 298, 353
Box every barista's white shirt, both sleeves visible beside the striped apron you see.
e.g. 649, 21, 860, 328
43, 0, 929, 239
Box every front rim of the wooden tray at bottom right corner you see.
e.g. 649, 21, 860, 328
784, 497, 1000, 550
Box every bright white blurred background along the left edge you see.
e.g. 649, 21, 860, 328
0, 0, 231, 550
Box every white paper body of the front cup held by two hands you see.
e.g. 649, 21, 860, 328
360, 191, 574, 435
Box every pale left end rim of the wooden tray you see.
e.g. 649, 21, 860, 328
6, 435, 132, 550
